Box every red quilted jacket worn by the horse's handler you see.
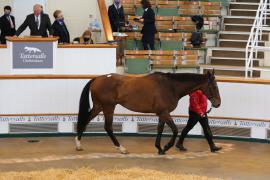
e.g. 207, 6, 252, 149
189, 90, 207, 116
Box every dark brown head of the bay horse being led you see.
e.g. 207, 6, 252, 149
201, 69, 221, 108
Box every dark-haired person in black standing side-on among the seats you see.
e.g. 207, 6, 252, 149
139, 0, 157, 50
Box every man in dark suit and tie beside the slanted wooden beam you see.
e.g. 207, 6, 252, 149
108, 0, 125, 32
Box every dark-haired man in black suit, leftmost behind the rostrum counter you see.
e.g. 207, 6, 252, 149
0, 6, 16, 44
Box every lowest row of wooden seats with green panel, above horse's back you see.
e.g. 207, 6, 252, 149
125, 50, 199, 73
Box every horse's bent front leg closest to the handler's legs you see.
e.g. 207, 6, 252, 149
160, 113, 178, 154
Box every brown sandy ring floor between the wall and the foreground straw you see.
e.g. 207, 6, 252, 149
0, 137, 270, 180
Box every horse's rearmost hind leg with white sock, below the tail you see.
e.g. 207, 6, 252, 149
75, 105, 102, 151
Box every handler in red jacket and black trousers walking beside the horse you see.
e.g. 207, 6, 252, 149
176, 90, 222, 152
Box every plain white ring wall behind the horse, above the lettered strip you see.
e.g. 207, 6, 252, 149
0, 79, 270, 120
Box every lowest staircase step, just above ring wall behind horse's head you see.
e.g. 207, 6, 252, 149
201, 65, 260, 77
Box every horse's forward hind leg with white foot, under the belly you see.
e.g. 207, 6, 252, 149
103, 106, 128, 154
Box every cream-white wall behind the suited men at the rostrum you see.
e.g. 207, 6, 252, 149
0, 0, 112, 41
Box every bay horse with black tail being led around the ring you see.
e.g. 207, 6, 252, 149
75, 70, 221, 155
